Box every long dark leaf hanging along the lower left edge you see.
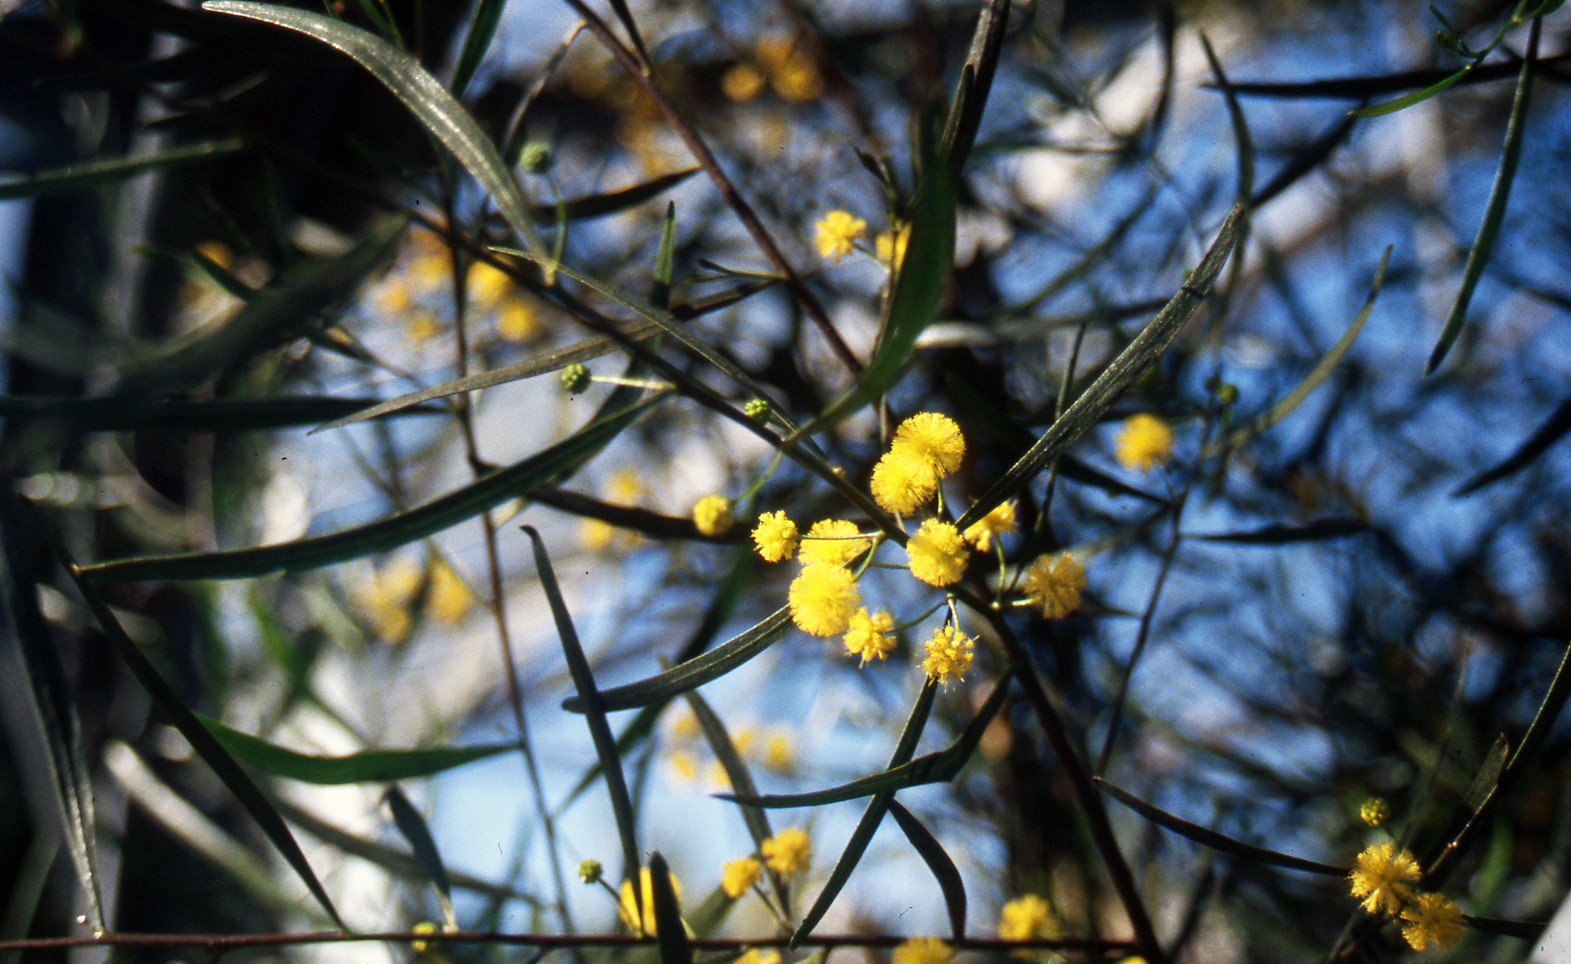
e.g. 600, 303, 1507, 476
0, 499, 104, 934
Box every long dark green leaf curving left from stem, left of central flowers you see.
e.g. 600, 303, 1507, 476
80, 394, 666, 582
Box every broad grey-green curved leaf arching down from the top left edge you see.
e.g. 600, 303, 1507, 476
203, 0, 551, 262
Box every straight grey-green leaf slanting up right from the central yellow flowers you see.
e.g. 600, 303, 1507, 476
955, 204, 1243, 531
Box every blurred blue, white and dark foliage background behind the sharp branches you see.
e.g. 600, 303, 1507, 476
0, 0, 1571, 961
